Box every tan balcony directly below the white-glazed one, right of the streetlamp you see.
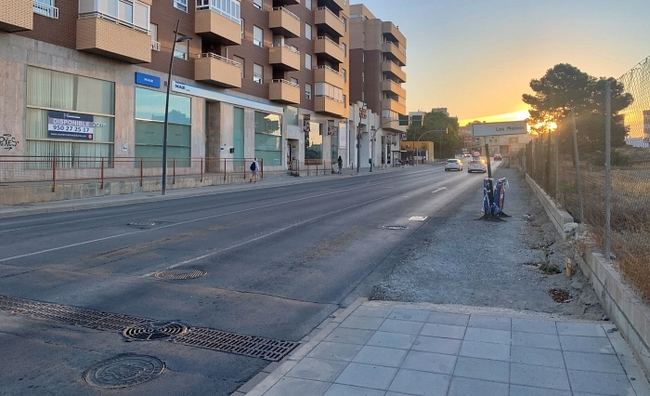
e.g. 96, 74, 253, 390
194, 52, 242, 88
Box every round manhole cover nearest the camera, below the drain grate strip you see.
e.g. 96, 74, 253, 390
84, 353, 165, 389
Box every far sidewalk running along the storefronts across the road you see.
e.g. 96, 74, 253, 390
0, 168, 402, 219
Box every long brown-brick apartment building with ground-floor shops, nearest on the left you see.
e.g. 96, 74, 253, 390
0, 0, 349, 183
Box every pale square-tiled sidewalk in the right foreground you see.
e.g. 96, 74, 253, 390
243, 299, 650, 396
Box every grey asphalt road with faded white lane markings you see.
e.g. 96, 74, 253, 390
0, 166, 483, 395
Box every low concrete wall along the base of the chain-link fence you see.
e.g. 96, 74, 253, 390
526, 170, 650, 377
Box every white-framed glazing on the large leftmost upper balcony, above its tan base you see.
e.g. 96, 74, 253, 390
79, 0, 150, 34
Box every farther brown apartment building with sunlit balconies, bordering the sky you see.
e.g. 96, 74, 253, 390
350, 4, 408, 166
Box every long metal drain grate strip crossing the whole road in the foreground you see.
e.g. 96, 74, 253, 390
0, 295, 300, 362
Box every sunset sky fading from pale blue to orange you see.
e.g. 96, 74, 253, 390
360, 0, 650, 125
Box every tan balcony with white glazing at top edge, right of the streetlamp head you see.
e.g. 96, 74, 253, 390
194, 0, 242, 45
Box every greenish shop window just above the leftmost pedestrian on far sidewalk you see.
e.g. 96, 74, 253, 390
255, 111, 282, 166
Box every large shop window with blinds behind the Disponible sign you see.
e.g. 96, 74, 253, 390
25, 66, 115, 168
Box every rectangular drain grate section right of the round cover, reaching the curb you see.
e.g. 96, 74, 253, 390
172, 327, 299, 362
